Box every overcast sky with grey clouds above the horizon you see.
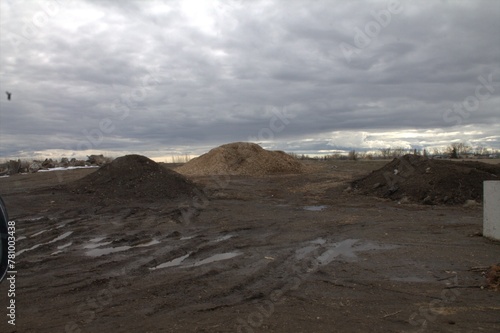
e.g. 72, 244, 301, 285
0, 0, 500, 159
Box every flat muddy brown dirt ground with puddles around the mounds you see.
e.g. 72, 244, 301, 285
0, 161, 500, 333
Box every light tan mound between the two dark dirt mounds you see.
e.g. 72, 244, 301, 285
176, 142, 303, 176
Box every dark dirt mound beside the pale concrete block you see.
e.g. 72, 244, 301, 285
352, 155, 500, 205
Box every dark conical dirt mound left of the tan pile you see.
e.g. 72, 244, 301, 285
70, 155, 195, 199
